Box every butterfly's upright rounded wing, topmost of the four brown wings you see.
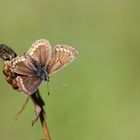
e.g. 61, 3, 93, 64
26, 39, 51, 67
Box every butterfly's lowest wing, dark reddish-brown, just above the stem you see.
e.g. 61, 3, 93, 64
16, 76, 42, 95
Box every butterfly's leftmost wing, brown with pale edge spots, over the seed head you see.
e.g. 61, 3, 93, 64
8, 55, 36, 76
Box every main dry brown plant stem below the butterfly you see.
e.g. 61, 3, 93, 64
31, 91, 51, 140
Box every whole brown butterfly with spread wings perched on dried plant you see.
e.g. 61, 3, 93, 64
8, 39, 78, 95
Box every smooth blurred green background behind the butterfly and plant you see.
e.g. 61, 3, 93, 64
0, 0, 140, 140
